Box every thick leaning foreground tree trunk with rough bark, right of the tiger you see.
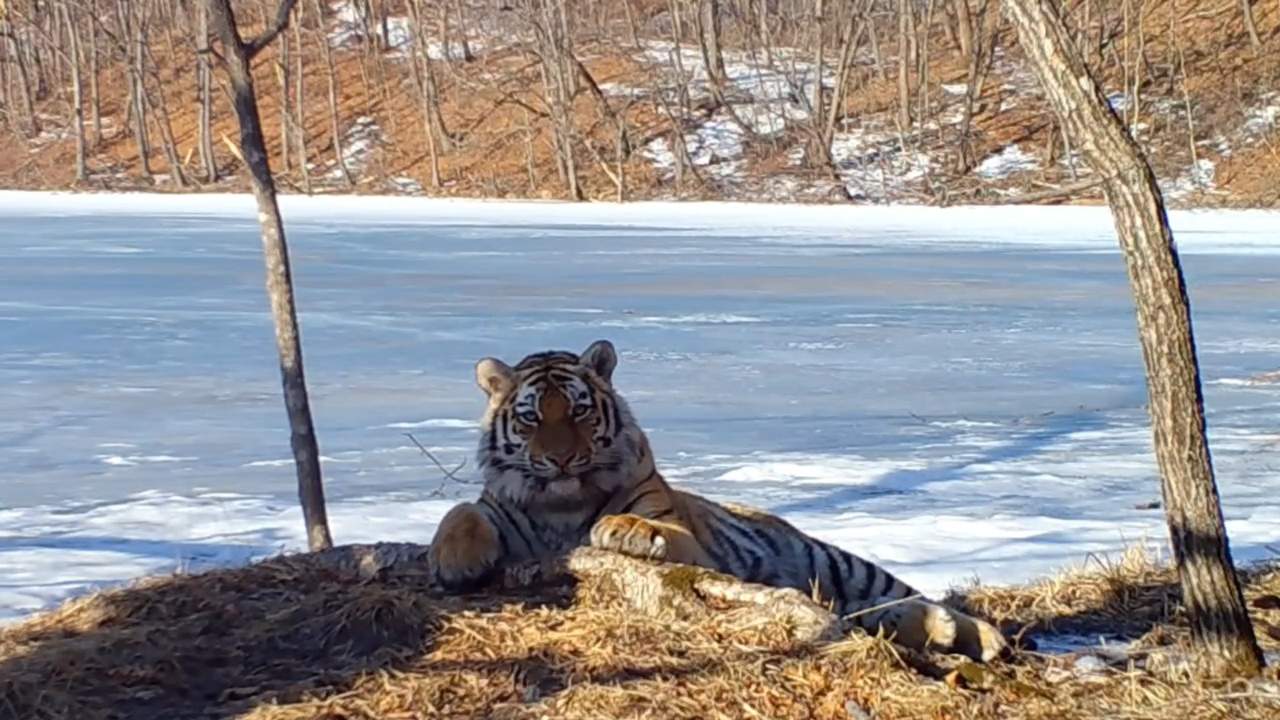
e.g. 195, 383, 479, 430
1005, 0, 1262, 676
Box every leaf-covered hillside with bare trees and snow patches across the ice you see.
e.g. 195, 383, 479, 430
0, 0, 1280, 206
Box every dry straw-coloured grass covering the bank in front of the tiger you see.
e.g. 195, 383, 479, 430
0, 543, 1280, 720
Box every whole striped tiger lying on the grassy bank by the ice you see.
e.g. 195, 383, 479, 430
429, 340, 1009, 661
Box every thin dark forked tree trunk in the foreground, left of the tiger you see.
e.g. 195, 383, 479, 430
206, 0, 333, 552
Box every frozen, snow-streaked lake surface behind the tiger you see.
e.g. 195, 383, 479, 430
0, 192, 1280, 619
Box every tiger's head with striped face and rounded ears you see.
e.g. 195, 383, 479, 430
476, 340, 652, 512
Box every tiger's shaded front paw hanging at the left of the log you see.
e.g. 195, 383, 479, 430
428, 503, 502, 591
